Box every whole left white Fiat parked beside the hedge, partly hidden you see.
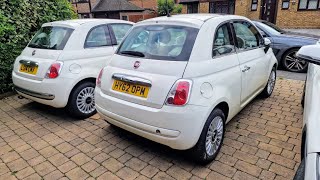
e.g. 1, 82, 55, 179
12, 19, 133, 118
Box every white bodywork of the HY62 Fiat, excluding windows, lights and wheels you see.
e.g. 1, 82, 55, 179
95, 14, 277, 150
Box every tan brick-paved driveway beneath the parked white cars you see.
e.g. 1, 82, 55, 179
0, 79, 303, 180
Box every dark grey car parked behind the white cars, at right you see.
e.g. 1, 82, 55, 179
253, 20, 320, 72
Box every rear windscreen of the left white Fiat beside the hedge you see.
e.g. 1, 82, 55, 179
28, 26, 73, 50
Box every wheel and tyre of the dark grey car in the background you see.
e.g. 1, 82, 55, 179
281, 48, 308, 73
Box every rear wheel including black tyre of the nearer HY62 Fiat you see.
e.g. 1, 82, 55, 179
190, 108, 226, 164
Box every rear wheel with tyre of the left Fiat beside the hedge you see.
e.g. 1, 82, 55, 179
66, 81, 97, 119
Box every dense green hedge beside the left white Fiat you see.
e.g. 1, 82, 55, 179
0, 0, 76, 94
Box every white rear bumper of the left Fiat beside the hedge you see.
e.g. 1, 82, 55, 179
12, 72, 72, 108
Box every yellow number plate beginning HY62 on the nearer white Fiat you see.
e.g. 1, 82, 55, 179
112, 80, 150, 98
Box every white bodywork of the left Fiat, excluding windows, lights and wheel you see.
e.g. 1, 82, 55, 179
12, 19, 133, 108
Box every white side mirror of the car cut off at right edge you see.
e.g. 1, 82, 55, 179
297, 44, 320, 65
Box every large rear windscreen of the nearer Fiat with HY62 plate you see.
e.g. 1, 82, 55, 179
117, 25, 199, 61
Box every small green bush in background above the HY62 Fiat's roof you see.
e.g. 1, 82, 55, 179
158, 0, 182, 16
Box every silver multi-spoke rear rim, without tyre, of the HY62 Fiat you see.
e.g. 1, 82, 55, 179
205, 116, 223, 156
